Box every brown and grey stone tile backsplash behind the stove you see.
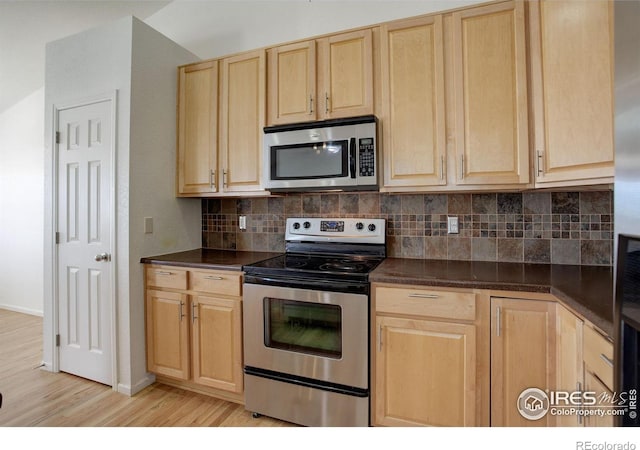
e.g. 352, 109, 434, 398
202, 191, 613, 266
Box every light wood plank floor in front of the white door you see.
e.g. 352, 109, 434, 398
0, 309, 292, 427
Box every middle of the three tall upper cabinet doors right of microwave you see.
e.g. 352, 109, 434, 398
451, 1, 529, 185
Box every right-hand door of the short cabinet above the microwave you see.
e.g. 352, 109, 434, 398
316, 29, 373, 119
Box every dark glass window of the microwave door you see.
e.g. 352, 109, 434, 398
271, 140, 349, 180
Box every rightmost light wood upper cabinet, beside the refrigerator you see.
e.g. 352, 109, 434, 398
528, 0, 614, 187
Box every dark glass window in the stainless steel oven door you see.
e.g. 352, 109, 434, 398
264, 297, 342, 359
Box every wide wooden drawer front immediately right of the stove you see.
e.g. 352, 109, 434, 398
375, 287, 476, 320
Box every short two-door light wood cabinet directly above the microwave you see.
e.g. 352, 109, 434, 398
268, 29, 373, 125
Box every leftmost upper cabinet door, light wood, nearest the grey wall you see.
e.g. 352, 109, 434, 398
177, 61, 218, 195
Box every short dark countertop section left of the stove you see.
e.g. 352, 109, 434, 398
140, 248, 281, 271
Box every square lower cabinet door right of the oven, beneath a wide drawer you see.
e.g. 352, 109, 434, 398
374, 316, 476, 426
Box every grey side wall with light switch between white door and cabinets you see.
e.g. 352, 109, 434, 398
127, 18, 201, 393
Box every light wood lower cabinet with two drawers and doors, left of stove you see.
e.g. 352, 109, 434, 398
145, 265, 243, 400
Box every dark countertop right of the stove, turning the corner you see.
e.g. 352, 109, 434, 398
369, 258, 613, 336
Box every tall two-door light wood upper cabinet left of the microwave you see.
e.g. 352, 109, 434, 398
177, 50, 266, 197
